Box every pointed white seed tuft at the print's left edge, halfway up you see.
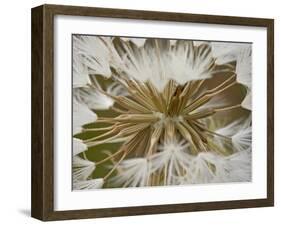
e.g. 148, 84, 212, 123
73, 98, 97, 134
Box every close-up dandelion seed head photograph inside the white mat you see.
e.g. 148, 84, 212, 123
70, 34, 252, 191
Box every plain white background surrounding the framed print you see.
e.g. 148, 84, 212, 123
0, 0, 276, 226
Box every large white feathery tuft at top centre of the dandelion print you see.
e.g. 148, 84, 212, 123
112, 39, 214, 91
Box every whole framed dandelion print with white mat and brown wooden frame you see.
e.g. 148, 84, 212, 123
32, 5, 274, 221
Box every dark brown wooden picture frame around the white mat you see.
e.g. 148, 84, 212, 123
31, 5, 274, 221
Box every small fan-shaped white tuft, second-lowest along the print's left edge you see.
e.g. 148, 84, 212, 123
72, 156, 96, 181
